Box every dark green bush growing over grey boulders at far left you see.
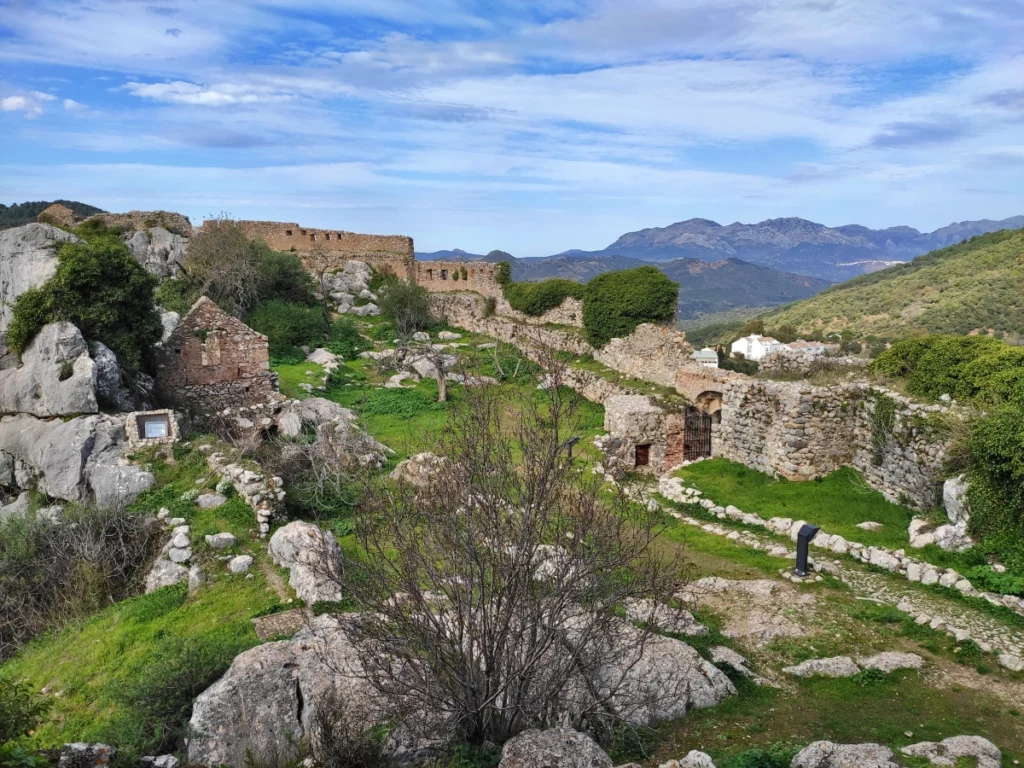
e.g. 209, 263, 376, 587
7, 237, 163, 370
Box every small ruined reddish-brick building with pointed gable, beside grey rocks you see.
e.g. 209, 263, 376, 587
156, 296, 278, 415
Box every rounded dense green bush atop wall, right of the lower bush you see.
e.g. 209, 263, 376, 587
583, 266, 679, 347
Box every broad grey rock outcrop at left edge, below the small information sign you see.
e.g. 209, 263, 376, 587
0, 414, 154, 509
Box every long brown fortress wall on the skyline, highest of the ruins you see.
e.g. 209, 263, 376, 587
203, 219, 415, 280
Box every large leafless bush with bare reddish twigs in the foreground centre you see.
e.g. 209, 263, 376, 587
323, 370, 688, 744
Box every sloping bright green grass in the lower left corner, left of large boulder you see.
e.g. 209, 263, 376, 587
3, 570, 279, 755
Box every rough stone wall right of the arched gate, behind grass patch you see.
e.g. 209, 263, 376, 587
713, 377, 946, 509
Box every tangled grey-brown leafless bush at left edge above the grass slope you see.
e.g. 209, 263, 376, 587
0, 508, 156, 659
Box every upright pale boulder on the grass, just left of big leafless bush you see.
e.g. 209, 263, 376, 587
268, 520, 342, 605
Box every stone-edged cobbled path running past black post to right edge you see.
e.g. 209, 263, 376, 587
627, 485, 1024, 666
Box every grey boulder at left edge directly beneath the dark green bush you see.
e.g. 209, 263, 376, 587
0, 323, 98, 416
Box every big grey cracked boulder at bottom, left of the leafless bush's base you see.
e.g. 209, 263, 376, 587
186, 615, 403, 768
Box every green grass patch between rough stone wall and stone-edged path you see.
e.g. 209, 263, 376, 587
678, 459, 913, 549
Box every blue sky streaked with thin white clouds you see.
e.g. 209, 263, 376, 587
0, 0, 1024, 257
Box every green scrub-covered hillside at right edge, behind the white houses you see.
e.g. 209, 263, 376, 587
762, 229, 1024, 338
